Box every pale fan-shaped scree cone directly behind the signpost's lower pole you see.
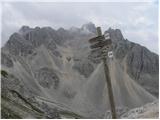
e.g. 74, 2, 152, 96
75, 59, 157, 118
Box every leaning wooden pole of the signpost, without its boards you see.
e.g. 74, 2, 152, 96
97, 27, 116, 119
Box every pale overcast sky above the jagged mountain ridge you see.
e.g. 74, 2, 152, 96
1, 0, 158, 53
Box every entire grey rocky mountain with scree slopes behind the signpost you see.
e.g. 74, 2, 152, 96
1, 23, 159, 118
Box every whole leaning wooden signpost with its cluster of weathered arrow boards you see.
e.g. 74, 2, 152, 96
89, 27, 116, 119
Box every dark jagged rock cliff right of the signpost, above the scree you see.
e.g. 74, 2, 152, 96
106, 28, 159, 97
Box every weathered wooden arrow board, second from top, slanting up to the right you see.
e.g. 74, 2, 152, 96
90, 39, 112, 49
